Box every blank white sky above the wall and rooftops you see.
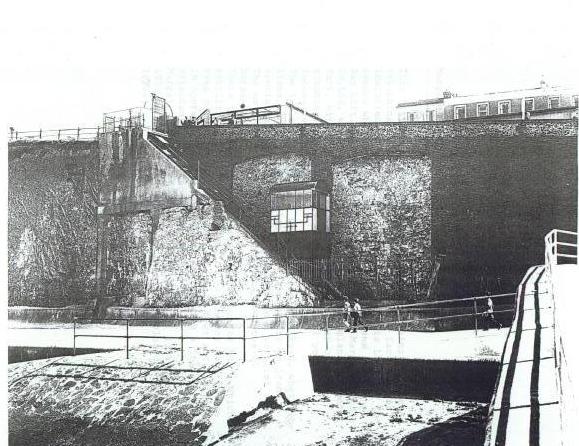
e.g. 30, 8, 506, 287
0, 0, 579, 131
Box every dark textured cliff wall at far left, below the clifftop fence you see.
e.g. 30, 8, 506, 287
8, 142, 98, 305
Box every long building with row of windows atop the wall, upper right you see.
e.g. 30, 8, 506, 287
396, 82, 579, 122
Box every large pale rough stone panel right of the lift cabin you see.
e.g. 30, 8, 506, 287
332, 157, 431, 290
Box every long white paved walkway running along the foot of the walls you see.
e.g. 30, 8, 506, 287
8, 322, 508, 360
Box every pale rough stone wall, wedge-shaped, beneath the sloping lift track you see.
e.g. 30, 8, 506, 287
101, 204, 315, 307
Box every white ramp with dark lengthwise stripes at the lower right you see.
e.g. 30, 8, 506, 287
485, 266, 561, 446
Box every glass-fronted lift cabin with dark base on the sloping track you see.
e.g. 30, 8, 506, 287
271, 180, 330, 259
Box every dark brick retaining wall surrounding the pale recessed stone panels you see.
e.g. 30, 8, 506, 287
173, 120, 577, 297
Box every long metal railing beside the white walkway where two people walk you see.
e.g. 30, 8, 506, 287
73, 293, 515, 362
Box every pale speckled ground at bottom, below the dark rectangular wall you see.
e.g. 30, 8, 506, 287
219, 394, 484, 446
